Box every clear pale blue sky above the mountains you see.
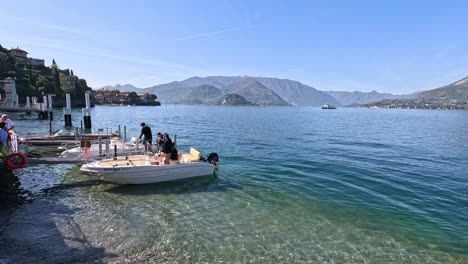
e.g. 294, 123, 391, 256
0, 0, 468, 94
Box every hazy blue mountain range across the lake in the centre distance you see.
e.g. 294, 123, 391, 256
99, 76, 436, 106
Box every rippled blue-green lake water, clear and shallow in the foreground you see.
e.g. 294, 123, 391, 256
0, 105, 468, 264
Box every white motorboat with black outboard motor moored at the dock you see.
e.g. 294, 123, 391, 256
80, 148, 219, 184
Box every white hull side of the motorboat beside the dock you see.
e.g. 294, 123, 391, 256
81, 161, 216, 184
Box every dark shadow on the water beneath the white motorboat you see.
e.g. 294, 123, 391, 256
106, 175, 242, 196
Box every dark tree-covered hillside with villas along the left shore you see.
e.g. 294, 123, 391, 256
0, 45, 161, 106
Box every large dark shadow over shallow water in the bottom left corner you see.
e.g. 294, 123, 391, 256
0, 168, 116, 263
